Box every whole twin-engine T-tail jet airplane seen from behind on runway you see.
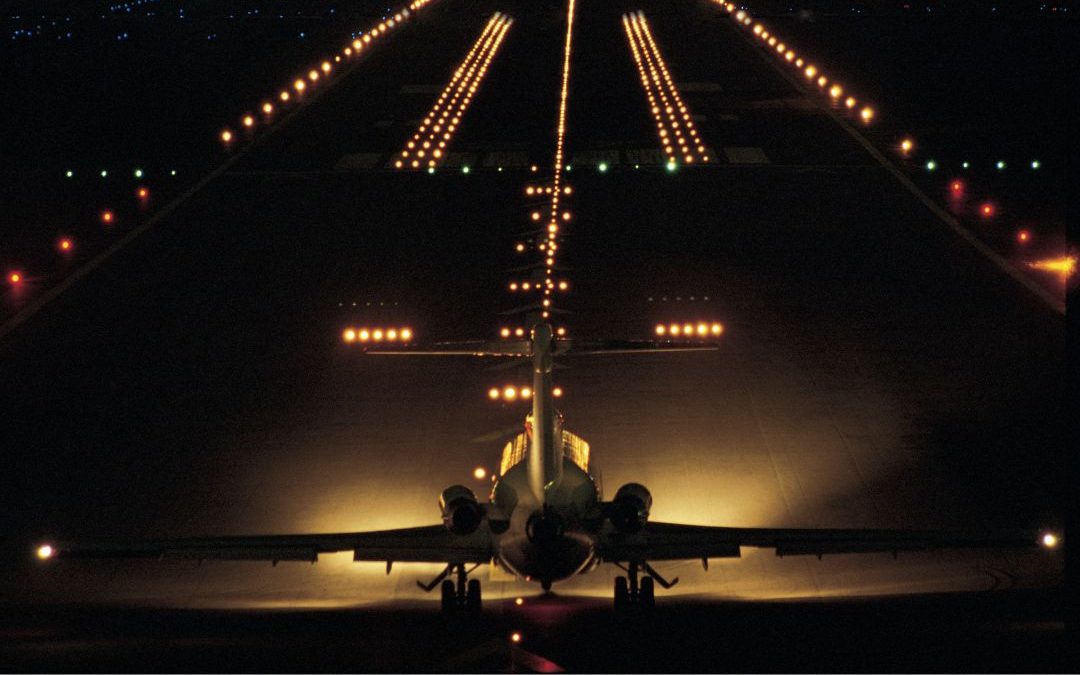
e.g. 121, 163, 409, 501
37, 318, 1062, 613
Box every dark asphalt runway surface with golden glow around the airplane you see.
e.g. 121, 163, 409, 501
0, 0, 1065, 670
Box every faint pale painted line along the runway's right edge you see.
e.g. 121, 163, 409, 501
708, 14, 1065, 315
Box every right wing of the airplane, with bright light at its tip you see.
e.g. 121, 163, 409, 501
599, 523, 1057, 563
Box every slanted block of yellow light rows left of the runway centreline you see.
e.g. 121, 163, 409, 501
393, 12, 514, 171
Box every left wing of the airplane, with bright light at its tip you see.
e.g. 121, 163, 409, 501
38, 525, 492, 564
